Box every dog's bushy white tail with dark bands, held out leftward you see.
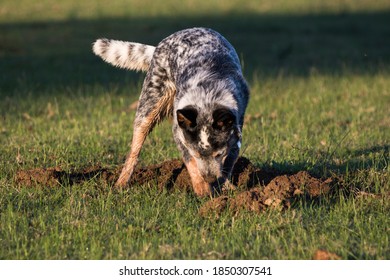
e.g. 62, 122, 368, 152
92, 39, 155, 71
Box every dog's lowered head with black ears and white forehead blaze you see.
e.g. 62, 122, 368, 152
176, 105, 241, 183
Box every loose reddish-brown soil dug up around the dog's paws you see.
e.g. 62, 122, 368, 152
15, 157, 332, 218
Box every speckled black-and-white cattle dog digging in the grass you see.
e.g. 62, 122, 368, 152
93, 28, 249, 196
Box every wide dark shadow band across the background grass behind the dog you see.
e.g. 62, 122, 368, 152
0, 11, 390, 95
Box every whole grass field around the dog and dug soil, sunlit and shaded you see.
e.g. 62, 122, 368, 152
0, 0, 390, 259
